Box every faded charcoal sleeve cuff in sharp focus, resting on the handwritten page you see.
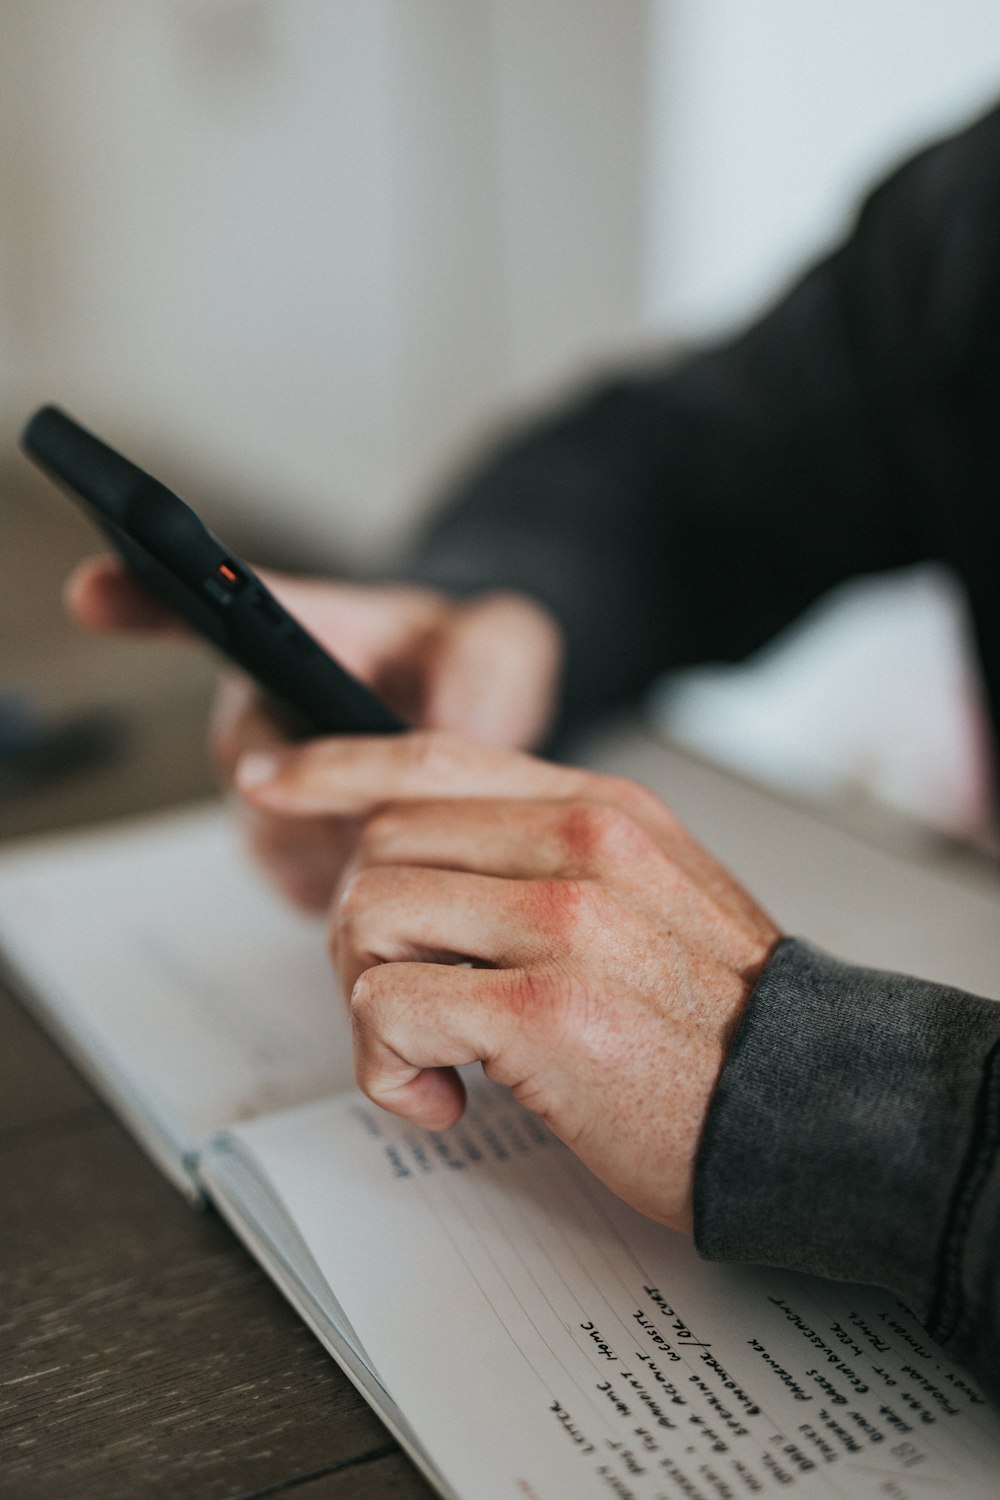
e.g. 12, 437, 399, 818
694, 939, 1000, 1400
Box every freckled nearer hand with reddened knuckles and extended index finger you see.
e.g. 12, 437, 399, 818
237, 734, 781, 1232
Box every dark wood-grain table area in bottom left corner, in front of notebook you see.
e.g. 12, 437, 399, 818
0, 993, 432, 1500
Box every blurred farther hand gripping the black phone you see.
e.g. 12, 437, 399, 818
66, 558, 562, 911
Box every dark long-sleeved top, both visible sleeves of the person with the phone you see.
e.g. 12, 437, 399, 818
411, 110, 1000, 1398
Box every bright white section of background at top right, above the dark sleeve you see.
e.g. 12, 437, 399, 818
646, 0, 1000, 338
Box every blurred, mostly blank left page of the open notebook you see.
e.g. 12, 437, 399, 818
0, 806, 352, 1154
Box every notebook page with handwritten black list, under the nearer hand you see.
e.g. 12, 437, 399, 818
218, 1080, 1000, 1500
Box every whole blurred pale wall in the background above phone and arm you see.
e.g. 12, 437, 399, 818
7, 0, 1000, 564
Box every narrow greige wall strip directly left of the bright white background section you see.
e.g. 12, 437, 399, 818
490, 0, 652, 399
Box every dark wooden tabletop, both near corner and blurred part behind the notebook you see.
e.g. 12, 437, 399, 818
0, 462, 432, 1500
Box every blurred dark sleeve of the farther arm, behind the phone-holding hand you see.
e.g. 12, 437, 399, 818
408, 102, 1000, 735
